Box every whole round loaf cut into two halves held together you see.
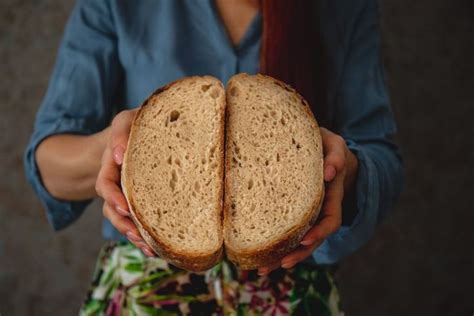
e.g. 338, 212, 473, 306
122, 74, 324, 271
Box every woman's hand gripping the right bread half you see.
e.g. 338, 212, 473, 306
258, 128, 358, 275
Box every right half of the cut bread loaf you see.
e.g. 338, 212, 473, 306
224, 74, 324, 270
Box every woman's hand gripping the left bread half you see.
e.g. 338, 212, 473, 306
95, 110, 155, 256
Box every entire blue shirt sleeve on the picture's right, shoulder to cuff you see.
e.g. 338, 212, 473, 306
313, 0, 403, 264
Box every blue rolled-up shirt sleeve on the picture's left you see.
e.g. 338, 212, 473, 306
24, 0, 120, 230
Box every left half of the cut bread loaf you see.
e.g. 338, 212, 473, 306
122, 76, 226, 271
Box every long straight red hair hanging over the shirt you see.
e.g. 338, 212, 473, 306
260, 0, 326, 123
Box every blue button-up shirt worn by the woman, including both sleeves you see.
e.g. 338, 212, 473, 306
24, 0, 402, 263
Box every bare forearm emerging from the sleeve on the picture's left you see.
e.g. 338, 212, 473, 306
35, 128, 109, 201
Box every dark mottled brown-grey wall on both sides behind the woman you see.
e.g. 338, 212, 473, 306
0, 0, 474, 316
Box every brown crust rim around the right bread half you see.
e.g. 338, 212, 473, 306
224, 74, 324, 270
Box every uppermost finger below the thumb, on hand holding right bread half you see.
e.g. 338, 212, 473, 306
301, 175, 344, 245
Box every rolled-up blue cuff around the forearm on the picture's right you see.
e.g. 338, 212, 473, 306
313, 141, 403, 264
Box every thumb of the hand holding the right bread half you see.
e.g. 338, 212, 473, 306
321, 128, 347, 182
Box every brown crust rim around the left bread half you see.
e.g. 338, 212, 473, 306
121, 76, 225, 271
